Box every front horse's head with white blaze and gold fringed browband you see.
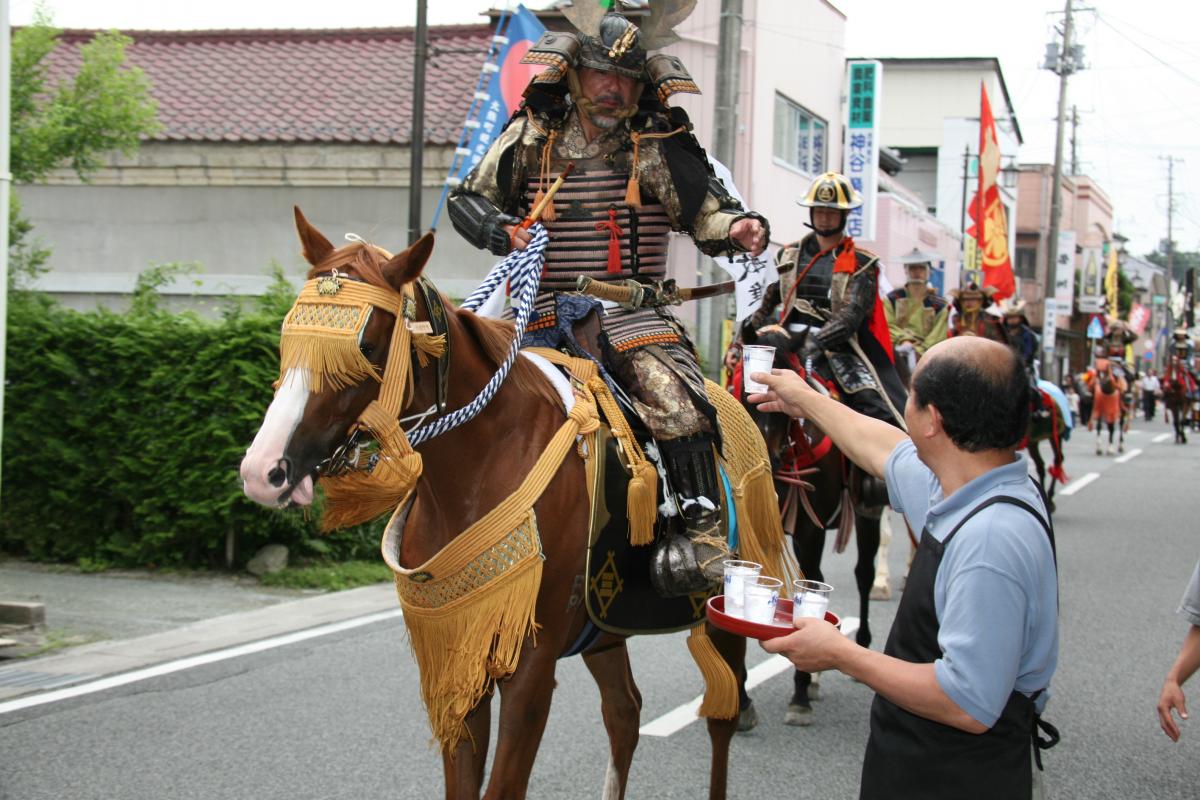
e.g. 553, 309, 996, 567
240, 207, 433, 507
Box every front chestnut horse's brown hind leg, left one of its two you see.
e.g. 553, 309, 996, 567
583, 638, 642, 800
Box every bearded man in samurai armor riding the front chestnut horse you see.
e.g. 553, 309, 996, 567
449, 2, 769, 596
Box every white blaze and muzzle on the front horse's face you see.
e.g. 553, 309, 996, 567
240, 369, 312, 506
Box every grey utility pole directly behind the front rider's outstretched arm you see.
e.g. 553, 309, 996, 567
697, 0, 742, 377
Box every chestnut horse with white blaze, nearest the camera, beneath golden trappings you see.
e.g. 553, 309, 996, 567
241, 209, 745, 800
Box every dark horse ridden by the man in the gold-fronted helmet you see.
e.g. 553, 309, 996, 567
729, 325, 884, 726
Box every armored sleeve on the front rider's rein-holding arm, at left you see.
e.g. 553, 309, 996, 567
446, 118, 527, 255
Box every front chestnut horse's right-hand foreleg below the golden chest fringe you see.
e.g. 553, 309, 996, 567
484, 640, 562, 800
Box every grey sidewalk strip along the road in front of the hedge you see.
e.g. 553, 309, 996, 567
0, 561, 397, 702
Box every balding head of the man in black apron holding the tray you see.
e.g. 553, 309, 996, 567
912, 336, 1030, 452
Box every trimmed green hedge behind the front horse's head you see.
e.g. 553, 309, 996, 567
0, 275, 379, 567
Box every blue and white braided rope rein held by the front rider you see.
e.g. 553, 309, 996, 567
408, 223, 550, 447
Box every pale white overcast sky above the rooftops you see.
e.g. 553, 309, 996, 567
10, 0, 1200, 253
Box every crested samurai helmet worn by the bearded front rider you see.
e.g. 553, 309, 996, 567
521, 0, 700, 102
